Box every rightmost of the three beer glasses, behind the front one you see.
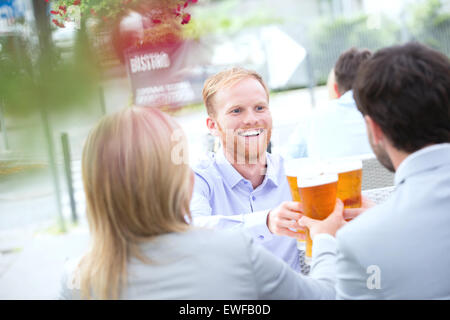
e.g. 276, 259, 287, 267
327, 159, 362, 208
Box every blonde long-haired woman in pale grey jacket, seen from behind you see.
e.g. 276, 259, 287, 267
61, 107, 342, 299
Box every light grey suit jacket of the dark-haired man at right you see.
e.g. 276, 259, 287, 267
336, 143, 450, 299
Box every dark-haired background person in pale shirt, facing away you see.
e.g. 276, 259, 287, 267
282, 48, 372, 159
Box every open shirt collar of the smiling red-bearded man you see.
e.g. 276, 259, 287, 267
215, 148, 280, 188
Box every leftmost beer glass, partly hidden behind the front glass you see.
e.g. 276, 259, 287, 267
284, 158, 314, 250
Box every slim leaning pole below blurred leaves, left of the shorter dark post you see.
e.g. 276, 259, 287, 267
41, 107, 66, 232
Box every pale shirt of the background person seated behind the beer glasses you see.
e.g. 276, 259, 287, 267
283, 90, 372, 159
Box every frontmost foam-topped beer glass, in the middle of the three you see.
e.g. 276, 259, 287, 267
297, 170, 338, 264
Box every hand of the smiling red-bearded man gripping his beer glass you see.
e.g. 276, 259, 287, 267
267, 201, 305, 239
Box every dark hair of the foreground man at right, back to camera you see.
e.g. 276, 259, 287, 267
353, 42, 450, 153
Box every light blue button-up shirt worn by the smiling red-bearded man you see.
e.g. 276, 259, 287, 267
191, 149, 300, 271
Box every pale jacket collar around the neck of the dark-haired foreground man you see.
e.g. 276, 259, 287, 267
394, 143, 450, 186
